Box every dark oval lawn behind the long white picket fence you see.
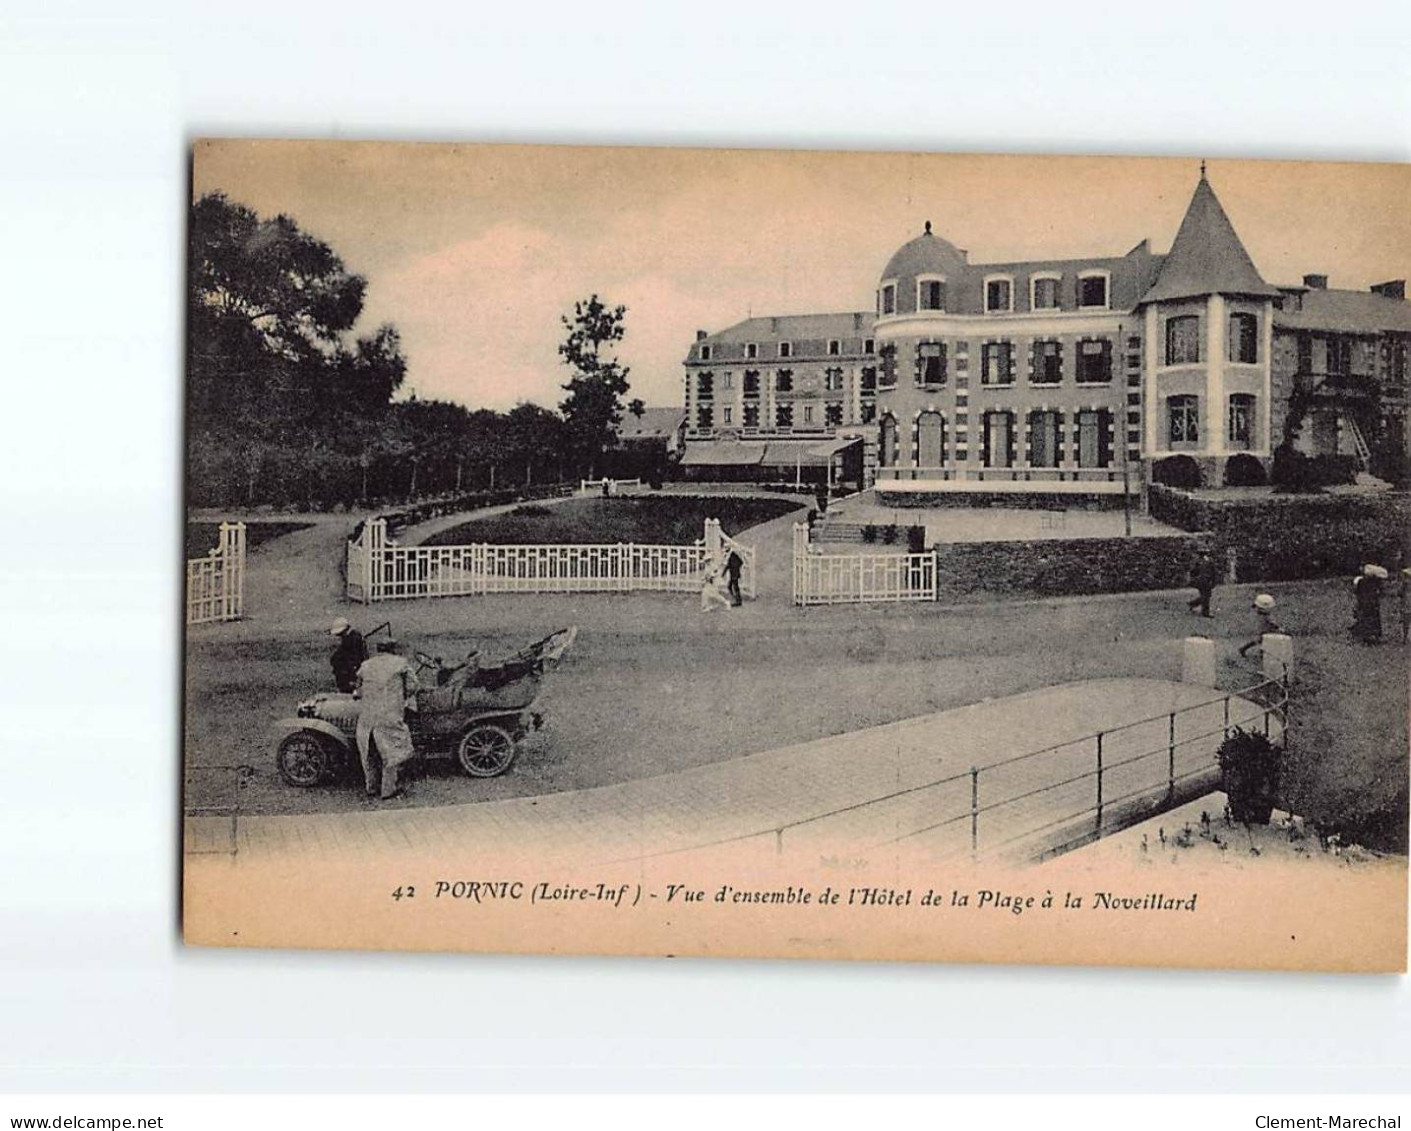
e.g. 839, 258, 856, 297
425, 495, 799, 546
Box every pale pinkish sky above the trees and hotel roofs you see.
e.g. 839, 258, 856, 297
192, 140, 1411, 409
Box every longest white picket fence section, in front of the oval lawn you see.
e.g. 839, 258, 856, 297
347, 519, 755, 604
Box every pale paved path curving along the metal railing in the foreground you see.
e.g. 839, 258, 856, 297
186, 680, 1277, 863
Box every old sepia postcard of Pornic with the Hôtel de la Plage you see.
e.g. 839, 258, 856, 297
182, 140, 1411, 972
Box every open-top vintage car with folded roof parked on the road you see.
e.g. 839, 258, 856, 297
275, 628, 579, 788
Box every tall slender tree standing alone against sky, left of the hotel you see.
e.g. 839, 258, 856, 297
559, 295, 629, 478
